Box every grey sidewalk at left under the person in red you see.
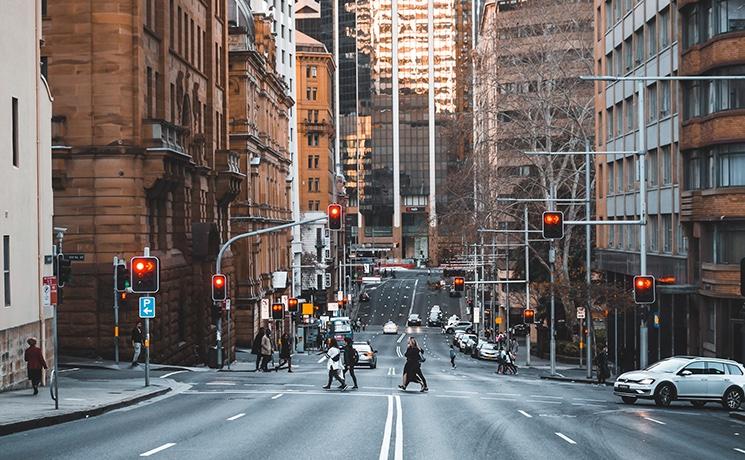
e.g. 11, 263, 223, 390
0, 374, 180, 436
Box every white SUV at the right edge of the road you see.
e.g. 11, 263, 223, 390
613, 356, 745, 410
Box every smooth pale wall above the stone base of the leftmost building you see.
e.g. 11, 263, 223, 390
0, 0, 53, 330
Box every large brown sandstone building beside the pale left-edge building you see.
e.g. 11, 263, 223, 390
43, 0, 237, 363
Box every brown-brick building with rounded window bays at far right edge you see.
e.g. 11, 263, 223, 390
671, 0, 745, 362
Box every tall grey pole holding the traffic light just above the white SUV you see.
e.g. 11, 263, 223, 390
636, 81, 649, 369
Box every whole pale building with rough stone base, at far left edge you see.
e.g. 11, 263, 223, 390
0, 0, 54, 391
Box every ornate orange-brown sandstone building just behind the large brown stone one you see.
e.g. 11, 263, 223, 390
228, 0, 294, 346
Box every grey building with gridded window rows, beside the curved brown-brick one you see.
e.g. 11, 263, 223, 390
595, 0, 697, 361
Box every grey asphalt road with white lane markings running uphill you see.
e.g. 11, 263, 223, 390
0, 274, 745, 460
